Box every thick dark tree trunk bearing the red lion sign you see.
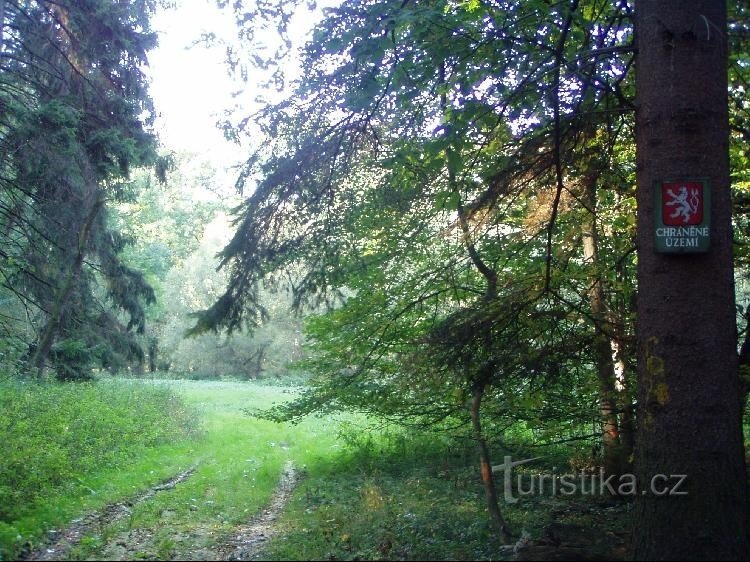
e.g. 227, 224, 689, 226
633, 0, 750, 560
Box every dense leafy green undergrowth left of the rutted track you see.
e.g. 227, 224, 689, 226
0, 381, 197, 556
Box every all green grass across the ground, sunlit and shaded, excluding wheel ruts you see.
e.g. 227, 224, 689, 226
0, 374, 627, 560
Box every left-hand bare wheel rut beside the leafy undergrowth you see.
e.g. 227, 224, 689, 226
19, 466, 196, 560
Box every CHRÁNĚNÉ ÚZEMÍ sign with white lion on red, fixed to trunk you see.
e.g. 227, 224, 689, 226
654, 179, 711, 254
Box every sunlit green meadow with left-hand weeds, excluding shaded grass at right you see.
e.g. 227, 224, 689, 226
0, 374, 340, 558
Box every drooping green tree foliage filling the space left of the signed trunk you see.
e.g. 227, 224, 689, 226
193, 0, 635, 434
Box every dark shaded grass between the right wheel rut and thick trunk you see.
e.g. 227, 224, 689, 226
262, 426, 626, 560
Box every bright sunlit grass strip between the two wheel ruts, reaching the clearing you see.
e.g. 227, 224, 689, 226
74, 381, 346, 558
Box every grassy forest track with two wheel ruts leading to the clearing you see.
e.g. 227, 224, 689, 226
13, 380, 332, 560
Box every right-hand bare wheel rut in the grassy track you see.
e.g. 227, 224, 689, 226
216, 461, 300, 560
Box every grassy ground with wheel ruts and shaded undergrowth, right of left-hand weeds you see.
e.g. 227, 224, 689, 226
11, 381, 630, 560
